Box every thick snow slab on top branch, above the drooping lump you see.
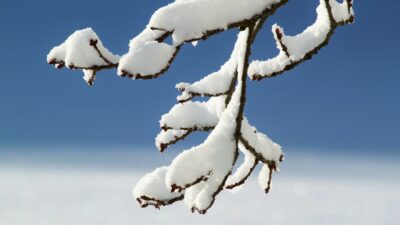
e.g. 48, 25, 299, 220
148, 0, 281, 44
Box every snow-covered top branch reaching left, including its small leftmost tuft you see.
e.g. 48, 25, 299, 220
47, 0, 287, 85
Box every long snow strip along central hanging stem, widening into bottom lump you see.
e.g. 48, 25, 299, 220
162, 29, 249, 213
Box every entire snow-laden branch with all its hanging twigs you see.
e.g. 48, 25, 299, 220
47, 0, 354, 214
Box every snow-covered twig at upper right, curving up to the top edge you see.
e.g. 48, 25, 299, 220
248, 0, 354, 79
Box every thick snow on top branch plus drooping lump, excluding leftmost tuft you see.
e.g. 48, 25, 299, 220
118, 0, 286, 78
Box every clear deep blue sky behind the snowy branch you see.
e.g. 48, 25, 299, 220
0, 0, 400, 152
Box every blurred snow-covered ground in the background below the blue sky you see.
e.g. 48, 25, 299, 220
0, 148, 400, 225
